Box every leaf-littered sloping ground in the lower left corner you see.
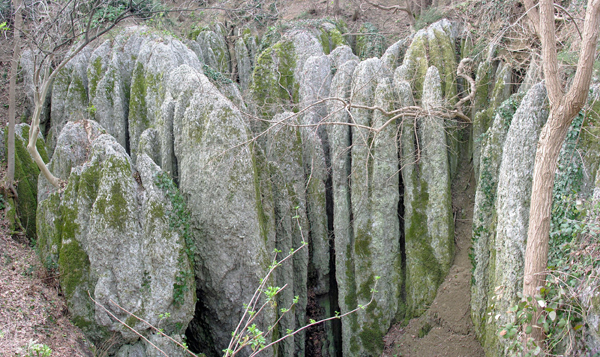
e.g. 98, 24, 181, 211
0, 222, 93, 357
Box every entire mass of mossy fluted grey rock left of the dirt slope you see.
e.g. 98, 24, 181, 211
25, 21, 548, 356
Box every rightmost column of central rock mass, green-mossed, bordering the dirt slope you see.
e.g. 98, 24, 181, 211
396, 67, 454, 315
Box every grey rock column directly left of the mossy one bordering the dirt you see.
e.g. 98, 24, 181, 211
352, 78, 404, 355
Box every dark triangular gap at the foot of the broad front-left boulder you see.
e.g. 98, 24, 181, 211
185, 289, 221, 357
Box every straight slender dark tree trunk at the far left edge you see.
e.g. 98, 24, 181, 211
6, 0, 22, 191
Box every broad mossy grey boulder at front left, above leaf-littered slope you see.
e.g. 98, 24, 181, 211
38, 121, 195, 356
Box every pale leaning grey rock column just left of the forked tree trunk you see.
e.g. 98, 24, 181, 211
486, 83, 548, 344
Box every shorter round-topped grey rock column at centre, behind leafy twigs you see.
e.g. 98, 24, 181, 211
265, 112, 312, 356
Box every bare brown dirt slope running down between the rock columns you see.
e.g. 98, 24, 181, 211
383, 149, 485, 357
